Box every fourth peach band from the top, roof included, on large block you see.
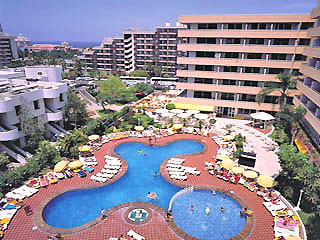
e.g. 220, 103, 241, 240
177, 57, 301, 68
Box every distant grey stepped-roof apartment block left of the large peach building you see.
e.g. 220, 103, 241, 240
81, 23, 184, 77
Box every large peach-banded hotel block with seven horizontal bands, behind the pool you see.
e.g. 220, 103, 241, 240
177, 14, 315, 117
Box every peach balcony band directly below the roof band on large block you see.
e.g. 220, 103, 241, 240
178, 29, 307, 38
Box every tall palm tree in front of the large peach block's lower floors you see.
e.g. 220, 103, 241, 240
256, 73, 297, 107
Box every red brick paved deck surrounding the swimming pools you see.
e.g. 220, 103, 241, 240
3, 134, 274, 240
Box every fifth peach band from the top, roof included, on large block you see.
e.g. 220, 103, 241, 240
177, 70, 279, 82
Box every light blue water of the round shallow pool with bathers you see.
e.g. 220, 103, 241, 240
172, 190, 246, 240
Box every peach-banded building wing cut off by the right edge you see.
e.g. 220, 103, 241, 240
293, 1, 320, 150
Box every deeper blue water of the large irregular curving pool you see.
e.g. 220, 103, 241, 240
43, 140, 204, 228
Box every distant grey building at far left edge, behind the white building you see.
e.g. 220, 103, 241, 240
0, 31, 18, 66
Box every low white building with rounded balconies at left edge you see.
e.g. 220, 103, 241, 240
0, 66, 68, 163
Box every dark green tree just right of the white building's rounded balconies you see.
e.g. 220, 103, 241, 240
65, 88, 88, 128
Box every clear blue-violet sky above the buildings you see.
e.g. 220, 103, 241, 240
0, 0, 317, 42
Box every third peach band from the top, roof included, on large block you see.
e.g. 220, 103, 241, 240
178, 43, 304, 54
